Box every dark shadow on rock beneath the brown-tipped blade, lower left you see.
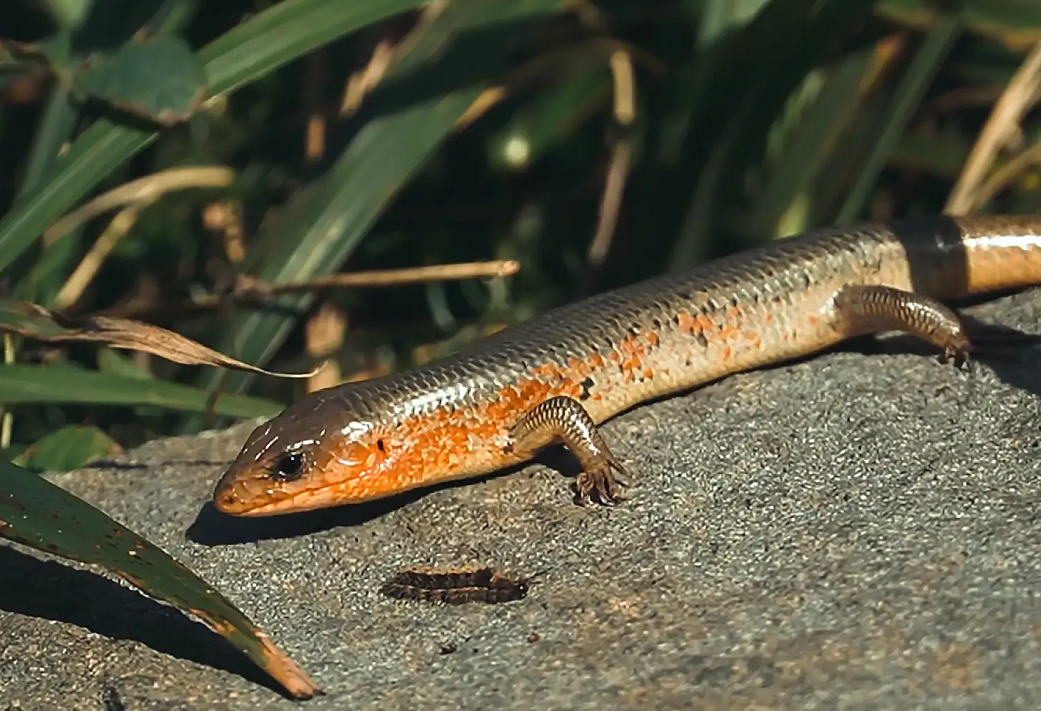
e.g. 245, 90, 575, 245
0, 547, 284, 694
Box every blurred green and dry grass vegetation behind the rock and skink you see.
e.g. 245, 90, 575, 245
0, 0, 1041, 468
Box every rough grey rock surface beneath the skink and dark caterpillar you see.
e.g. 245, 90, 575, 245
0, 290, 1041, 711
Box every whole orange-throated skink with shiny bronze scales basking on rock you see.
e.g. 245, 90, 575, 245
213, 217, 1041, 515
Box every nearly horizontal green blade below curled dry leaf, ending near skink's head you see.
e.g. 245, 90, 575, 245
0, 365, 282, 418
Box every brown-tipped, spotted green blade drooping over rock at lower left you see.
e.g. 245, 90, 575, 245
0, 460, 318, 699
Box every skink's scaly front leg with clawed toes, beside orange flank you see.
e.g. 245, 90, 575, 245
510, 396, 628, 506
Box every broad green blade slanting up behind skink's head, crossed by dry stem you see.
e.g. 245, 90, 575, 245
189, 0, 578, 412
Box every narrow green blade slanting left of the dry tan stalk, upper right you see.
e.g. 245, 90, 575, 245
836, 12, 963, 224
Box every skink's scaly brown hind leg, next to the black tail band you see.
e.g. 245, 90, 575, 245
833, 284, 972, 371
